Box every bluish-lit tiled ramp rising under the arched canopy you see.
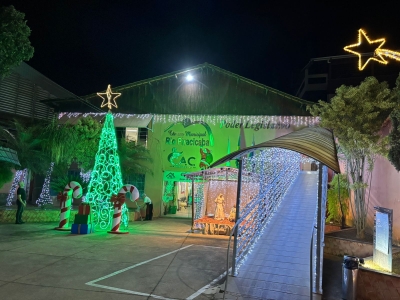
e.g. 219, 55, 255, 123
222, 172, 318, 300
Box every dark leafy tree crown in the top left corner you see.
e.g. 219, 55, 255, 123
0, 5, 34, 79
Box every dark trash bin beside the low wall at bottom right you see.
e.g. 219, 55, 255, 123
342, 255, 364, 300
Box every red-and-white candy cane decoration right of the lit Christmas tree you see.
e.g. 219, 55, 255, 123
108, 184, 139, 234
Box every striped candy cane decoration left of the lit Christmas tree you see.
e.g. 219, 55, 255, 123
54, 181, 82, 231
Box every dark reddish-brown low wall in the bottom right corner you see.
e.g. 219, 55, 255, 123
357, 267, 400, 300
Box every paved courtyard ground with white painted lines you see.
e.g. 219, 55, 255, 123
0, 218, 227, 300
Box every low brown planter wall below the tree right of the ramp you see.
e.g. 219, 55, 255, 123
324, 235, 374, 257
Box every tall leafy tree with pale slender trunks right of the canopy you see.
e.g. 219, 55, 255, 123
307, 77, 396, 238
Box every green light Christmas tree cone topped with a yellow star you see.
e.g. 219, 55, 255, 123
85, 86, 129, 230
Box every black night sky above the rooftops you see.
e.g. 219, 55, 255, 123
0, 0, 400, 96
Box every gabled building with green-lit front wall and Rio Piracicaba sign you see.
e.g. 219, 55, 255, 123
42, 63, 317, 216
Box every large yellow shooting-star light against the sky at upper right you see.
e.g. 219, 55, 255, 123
343, 29, 400, 71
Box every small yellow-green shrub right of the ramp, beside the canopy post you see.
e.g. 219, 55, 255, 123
327, 174, 350, 228
